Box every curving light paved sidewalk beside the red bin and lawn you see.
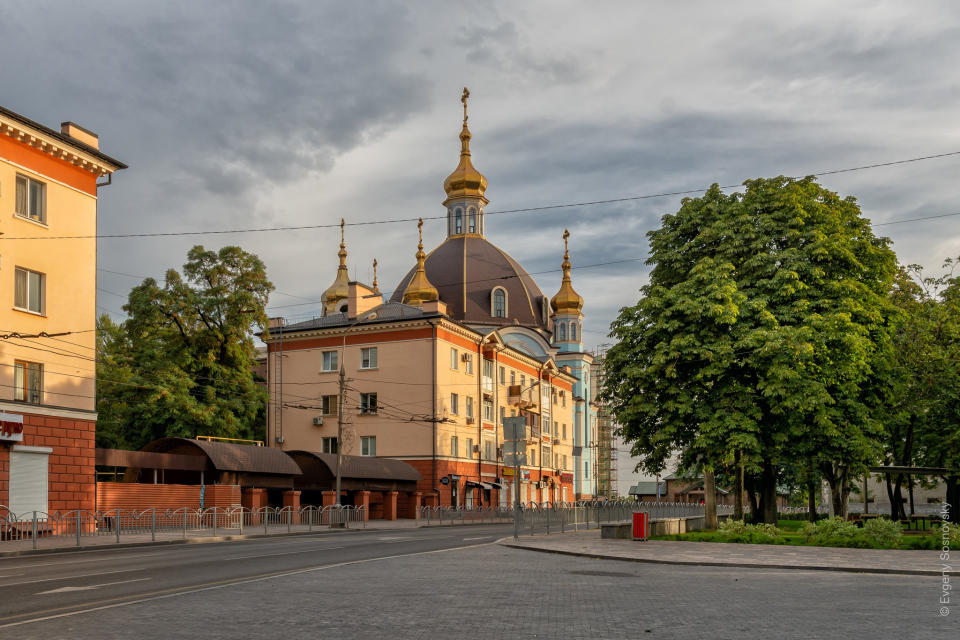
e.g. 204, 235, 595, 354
500, 529, 941, 576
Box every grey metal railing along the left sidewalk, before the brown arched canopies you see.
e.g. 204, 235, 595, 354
0, 505, 368, 549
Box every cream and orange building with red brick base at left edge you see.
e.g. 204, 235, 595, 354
0, 107, 126, 515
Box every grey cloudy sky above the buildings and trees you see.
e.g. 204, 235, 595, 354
0, 0, 960, 346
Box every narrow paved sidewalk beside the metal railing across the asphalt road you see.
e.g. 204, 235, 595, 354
0, 518, 502, 558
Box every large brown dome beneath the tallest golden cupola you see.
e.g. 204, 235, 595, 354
390, 235, 550, 331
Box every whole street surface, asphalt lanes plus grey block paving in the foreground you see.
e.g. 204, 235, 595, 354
0, 525, 958, 640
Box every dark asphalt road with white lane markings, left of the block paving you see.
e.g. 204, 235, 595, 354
0, 525, 513, 637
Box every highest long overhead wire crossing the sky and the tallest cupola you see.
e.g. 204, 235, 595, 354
0, 151, 960, 241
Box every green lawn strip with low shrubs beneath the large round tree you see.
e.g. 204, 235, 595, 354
651, 520, 942, 550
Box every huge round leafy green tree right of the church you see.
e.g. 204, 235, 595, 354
603, 176, 896, 522
